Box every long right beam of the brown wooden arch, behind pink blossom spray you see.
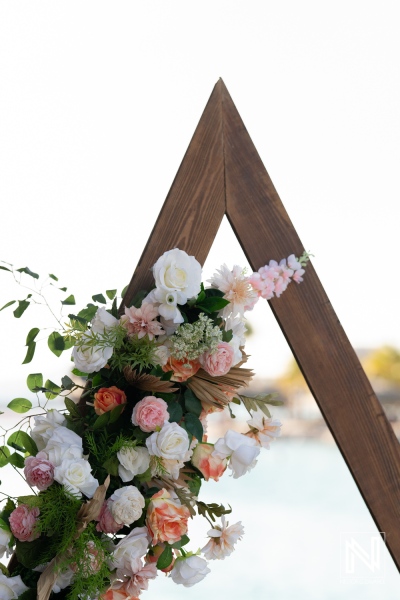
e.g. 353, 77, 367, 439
221, 78, 400, 568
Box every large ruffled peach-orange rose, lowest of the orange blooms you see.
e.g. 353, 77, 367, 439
146, 489, 190, 544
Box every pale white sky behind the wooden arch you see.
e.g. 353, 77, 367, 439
0, 0, 400, 399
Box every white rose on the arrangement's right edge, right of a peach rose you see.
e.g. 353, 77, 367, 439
212, 429, 260, 479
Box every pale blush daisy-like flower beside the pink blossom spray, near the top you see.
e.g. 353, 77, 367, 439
209, 265, 258, 319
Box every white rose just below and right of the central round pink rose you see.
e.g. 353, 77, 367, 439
146, 421, 189, 460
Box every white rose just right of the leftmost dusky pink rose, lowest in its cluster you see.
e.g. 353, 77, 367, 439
54, 458, 99, 498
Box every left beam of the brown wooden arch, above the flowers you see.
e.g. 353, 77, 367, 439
120, 84, 225, 312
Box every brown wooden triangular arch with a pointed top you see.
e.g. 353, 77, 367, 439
122, 80, 400, 568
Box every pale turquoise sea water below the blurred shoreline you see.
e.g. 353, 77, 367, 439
1, 438, 400, 600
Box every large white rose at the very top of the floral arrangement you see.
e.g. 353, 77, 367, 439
153, 248, 201, 304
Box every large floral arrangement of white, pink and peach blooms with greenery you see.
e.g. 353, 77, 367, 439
0, 248, 308, 600
